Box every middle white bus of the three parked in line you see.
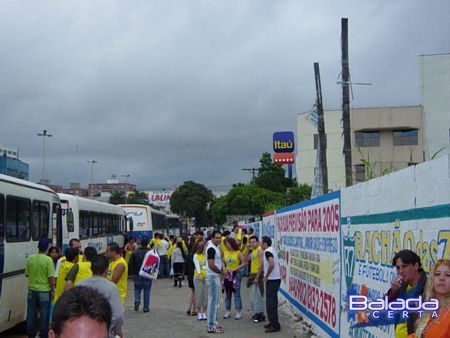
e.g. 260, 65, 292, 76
58, 194, 125, 253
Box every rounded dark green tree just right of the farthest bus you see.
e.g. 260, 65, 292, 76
170, 181, 214, 226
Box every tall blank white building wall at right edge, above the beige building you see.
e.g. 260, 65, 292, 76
419, 54, 450, 160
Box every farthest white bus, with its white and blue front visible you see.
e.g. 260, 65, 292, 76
120, 204, 168, 239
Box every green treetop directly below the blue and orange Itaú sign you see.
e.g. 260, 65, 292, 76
252, 152, 294, 192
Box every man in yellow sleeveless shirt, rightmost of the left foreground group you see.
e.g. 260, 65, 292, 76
106, 242, 128, 303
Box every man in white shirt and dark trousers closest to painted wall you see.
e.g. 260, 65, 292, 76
262, 236, 281, 333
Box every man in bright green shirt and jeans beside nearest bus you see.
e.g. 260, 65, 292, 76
25, 239, 55, 338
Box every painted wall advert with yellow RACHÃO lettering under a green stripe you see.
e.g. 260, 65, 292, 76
341, 204, 450, 337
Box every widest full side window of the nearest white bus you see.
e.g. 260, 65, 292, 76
6, 196, 31, 242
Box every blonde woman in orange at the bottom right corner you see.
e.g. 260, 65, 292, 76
408, 259, 450, 338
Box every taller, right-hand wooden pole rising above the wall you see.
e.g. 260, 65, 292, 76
341, 18, 353, 187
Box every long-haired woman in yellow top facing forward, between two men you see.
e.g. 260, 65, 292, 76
223, 237, 247, 319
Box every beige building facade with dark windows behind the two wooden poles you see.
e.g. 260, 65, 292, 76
296, 106, 424, 190
